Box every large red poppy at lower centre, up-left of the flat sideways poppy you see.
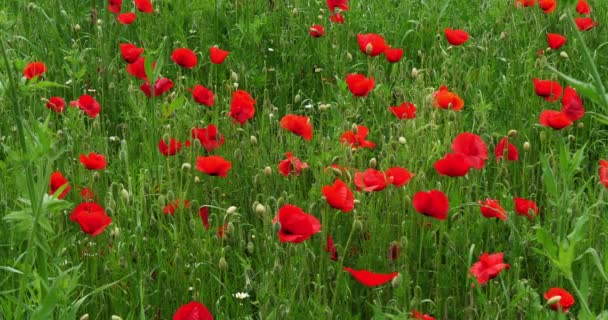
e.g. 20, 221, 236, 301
273, 204, 321, 243
